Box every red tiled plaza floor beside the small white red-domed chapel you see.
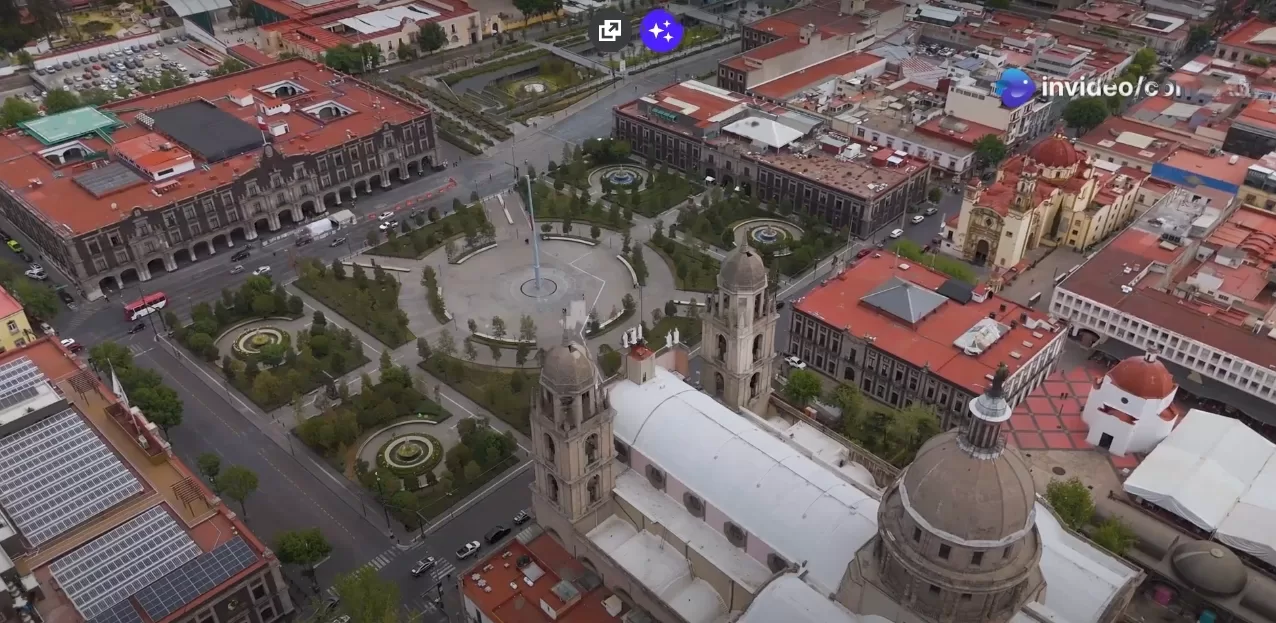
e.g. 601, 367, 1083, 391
1009, 361, 1138, 469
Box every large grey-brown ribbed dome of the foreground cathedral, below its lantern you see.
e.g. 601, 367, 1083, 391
900, 430, 1036, 541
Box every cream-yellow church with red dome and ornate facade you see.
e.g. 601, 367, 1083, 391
940, 134, 1147, 269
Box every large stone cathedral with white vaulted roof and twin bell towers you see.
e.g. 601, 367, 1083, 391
531, 249, 1142, 623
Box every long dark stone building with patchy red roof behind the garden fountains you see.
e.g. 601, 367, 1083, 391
612, 80, 931, 239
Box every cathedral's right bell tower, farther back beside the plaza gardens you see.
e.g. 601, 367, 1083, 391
701, 246, 780, 414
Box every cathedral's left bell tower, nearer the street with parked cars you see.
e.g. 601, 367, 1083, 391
531, 319, 616, 536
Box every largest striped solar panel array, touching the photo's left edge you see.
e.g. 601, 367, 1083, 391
0, 410, 142, 545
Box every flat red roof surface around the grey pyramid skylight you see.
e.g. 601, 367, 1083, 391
795, 251, 1063, 392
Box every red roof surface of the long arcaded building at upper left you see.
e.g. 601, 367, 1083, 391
0, 59, 429, 235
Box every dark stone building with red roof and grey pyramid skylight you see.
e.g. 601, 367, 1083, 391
787, 251, 1065, 428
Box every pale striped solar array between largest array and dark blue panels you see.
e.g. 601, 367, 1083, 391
50, 507, 199, 619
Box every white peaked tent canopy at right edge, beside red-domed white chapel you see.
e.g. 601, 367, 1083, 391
1125, 409, 1276, 564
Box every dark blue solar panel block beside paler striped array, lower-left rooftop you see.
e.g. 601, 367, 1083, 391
135, 536, 256, 620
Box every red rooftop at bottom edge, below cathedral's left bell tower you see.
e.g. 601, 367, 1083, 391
461, 534, 620, 623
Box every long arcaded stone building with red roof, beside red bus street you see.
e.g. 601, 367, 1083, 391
0, 59, 436, 300
